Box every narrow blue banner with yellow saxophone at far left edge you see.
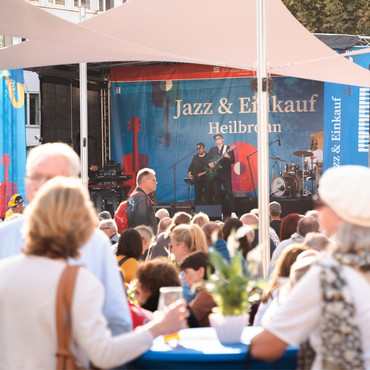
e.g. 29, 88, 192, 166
0, 69, 26, 218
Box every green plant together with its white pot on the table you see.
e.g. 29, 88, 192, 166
205, 226, 261, 344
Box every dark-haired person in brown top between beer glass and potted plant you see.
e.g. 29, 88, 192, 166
180, 252, 217, 326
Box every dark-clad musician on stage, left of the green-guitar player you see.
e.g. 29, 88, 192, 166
188, 143, 212, 205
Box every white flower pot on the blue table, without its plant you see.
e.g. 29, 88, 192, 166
209, 312, 249, 344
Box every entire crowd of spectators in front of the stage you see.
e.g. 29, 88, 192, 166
0, 143, 370, 369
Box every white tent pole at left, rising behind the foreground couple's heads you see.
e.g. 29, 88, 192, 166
79, 6, 88, 189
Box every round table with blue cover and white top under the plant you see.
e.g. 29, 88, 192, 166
129, 327, 298, 370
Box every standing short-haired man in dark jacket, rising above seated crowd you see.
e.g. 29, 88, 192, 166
127, 168, 157, 234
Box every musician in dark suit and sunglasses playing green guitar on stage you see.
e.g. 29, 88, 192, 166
208, 134, 236, 216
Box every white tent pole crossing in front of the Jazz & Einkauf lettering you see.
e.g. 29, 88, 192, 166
256, 0, 270, 277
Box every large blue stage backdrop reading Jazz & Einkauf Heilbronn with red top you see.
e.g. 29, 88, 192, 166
111, 61, 366, 202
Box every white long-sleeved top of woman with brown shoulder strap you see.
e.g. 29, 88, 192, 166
0, 254, 153, 369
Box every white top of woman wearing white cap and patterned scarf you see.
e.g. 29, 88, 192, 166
264, 266, 370, 369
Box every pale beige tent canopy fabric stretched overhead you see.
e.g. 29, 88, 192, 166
0, 0, 370, 87
